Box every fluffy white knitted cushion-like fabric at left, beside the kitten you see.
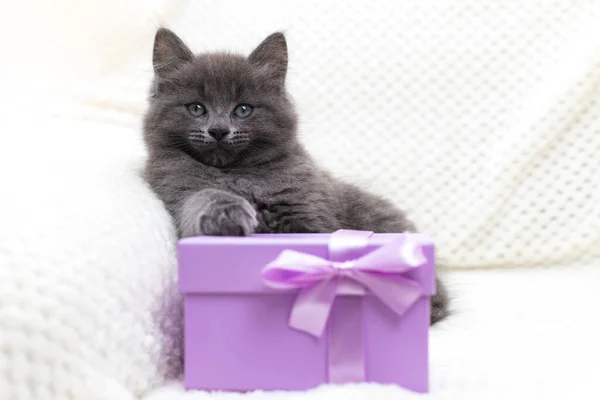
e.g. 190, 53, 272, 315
0, 112, 181, 400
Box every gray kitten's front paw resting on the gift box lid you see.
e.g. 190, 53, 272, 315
181, 192, 258, 237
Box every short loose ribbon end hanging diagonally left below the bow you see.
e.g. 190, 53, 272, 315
289, 279, 338, 337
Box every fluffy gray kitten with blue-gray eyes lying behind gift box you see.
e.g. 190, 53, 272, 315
144, 28, 448, 323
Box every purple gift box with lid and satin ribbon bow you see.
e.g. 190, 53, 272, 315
178, 230, 435, 392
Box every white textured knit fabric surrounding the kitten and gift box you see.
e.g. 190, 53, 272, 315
0, 0, 600, 400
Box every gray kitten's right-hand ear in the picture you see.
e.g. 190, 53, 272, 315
248, 32, 288, 88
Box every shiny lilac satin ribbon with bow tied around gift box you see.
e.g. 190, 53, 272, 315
262, 230, 426, 383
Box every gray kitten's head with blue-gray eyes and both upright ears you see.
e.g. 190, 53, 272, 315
145, 29, 296, 167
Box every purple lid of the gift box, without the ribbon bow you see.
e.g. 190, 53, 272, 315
177, 233, 435, 295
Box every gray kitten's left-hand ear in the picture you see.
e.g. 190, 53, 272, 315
152, 28, 194, 76
